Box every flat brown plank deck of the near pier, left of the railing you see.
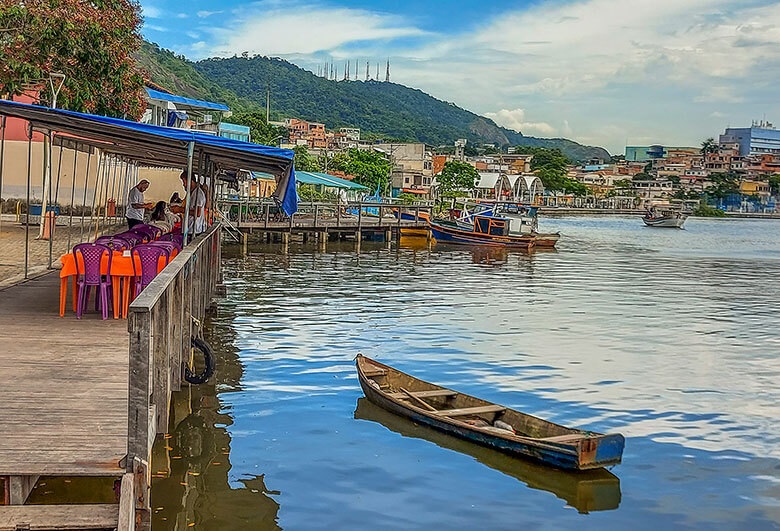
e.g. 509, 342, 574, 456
0, 271, 129, 477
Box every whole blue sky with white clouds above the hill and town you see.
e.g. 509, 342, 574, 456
141, 0, 780, 154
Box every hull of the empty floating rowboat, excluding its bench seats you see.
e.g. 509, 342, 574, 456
356, 355, 625, 470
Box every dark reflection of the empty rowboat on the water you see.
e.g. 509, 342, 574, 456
355, 398, 620, 513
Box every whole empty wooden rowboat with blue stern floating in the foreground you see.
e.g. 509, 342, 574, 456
355, 354, 625, 470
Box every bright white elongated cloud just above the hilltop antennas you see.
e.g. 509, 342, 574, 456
207, 6, 424, 56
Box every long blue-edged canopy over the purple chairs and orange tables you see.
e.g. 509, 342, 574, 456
0, 100, 298, 215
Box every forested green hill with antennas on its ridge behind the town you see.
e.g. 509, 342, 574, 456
138, 43, 609, 160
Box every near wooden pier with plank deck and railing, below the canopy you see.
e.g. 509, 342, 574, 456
0, 225, 221, 531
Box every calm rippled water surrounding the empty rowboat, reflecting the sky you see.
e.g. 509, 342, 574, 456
152, 217, 780, 531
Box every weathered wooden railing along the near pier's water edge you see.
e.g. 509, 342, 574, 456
125, 224, 221, 508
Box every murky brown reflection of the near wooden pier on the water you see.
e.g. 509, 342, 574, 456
152, 327, 281, 531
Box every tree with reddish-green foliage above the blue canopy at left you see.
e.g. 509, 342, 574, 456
0, 0, 145, 118
